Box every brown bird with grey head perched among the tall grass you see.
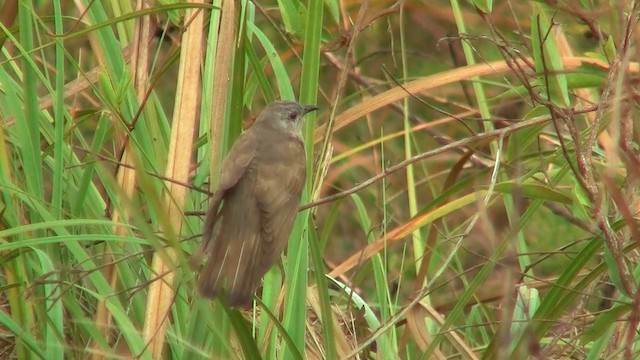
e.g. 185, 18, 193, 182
192, 101, 318, 307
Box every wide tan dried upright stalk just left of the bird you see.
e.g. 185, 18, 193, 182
143, 0, 205, 359
